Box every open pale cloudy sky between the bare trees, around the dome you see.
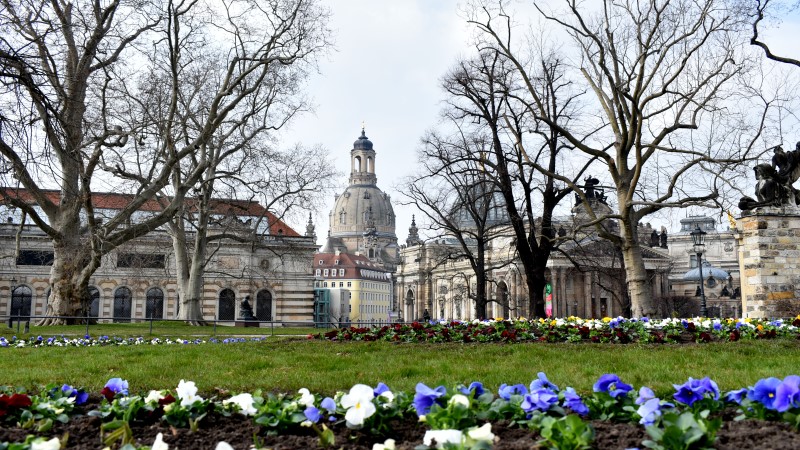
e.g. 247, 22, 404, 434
283, 0, 800, 245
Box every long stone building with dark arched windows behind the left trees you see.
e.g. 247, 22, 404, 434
0, 191, 316, 326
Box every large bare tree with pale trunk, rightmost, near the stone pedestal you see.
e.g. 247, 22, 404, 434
474, 0, 766, 316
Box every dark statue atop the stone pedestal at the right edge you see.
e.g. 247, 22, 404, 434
739, 142, 800, 211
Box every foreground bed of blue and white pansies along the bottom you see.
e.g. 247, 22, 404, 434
0, 373, 800, 450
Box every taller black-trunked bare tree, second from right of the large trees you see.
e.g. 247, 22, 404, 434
444, 41, 600, 317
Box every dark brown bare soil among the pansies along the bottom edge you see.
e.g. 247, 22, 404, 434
0, 408, 800, 450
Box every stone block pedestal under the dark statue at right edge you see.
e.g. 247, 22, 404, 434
736, 207, 800, 318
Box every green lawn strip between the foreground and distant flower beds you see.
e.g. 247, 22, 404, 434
0, 337, 800, 395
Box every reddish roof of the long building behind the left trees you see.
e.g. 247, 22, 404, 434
0, 187, 300, 237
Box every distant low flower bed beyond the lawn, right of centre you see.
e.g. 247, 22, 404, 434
308, 316, 800, 344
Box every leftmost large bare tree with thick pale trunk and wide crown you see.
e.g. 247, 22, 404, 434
0, 0, 328, 324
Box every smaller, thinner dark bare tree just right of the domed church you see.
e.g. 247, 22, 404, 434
398, 128, 512, 318
